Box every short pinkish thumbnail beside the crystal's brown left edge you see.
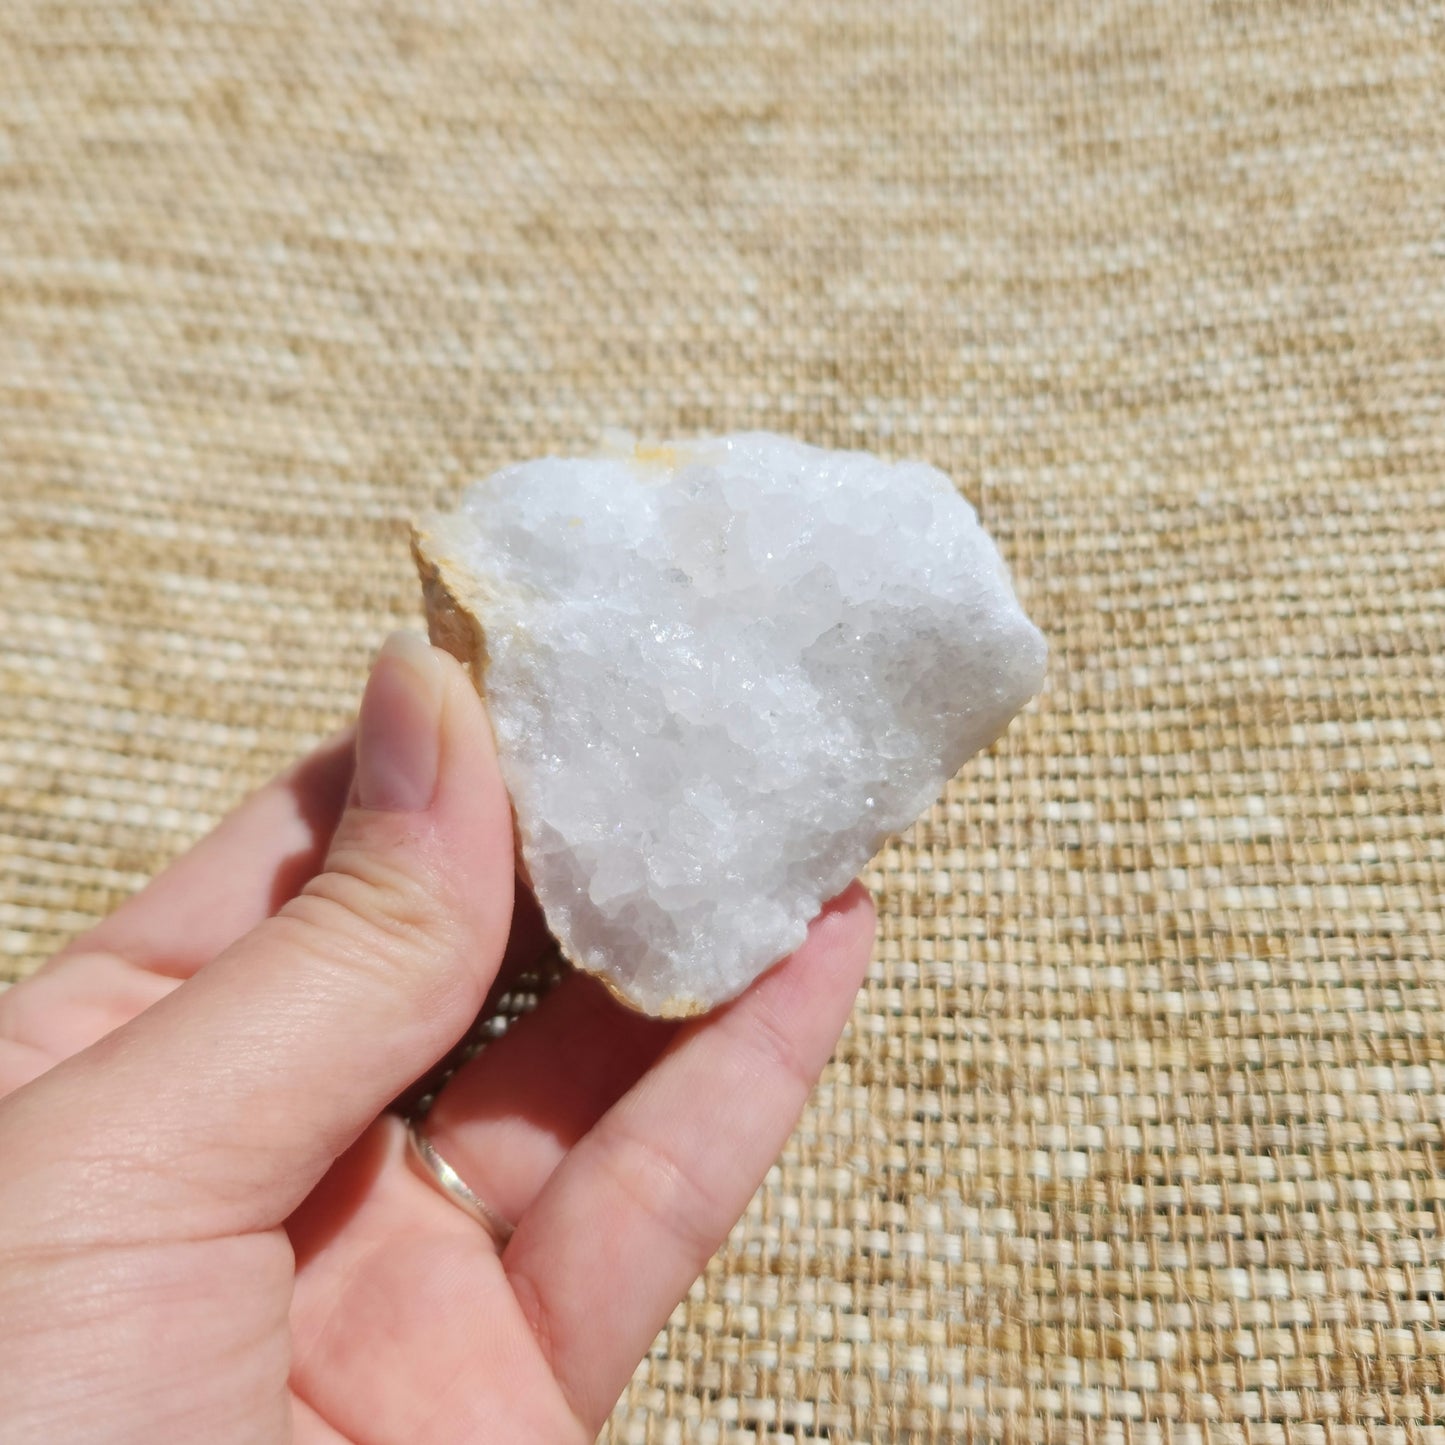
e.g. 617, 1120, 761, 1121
357, 631, 447, 812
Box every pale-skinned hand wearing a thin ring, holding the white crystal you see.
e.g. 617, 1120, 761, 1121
0, 637, 874, 1445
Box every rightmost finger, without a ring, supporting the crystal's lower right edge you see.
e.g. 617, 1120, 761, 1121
501, 884, 874, 1428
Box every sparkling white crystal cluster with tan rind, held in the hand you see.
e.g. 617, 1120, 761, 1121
418, 434, 1045, 1014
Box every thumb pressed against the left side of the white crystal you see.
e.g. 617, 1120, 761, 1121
0, 633, 513, 1240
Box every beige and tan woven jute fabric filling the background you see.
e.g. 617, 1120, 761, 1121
0, 0, 1445, 1445
